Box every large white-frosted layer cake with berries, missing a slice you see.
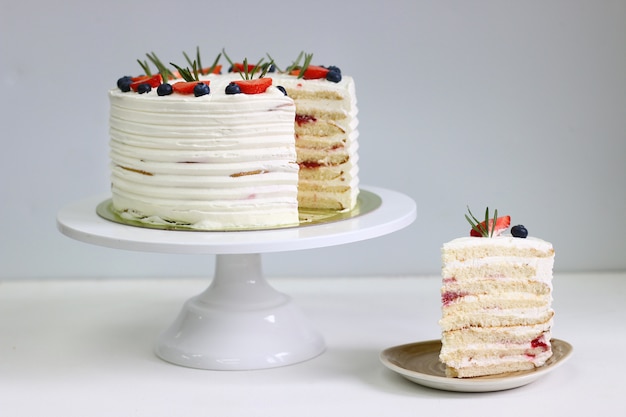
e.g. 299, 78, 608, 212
109, 53, 359, 230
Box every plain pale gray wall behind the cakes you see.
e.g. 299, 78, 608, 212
0, 0, 626, 279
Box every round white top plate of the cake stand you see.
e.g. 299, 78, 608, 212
57, 187, 417, 254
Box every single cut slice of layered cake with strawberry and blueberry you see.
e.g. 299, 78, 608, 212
439, 209, 554, 378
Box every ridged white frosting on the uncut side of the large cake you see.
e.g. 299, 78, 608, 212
109, 77, 298, 229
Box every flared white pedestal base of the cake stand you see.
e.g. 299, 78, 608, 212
156, 254, 325, 370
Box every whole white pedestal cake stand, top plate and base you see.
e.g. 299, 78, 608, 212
57, 187, 417, 370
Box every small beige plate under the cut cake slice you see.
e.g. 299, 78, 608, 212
380, 339, 573, 392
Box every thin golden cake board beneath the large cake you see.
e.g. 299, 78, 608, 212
96, 190, 382, 232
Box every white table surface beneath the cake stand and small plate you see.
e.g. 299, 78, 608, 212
0, 273, 626, 417
